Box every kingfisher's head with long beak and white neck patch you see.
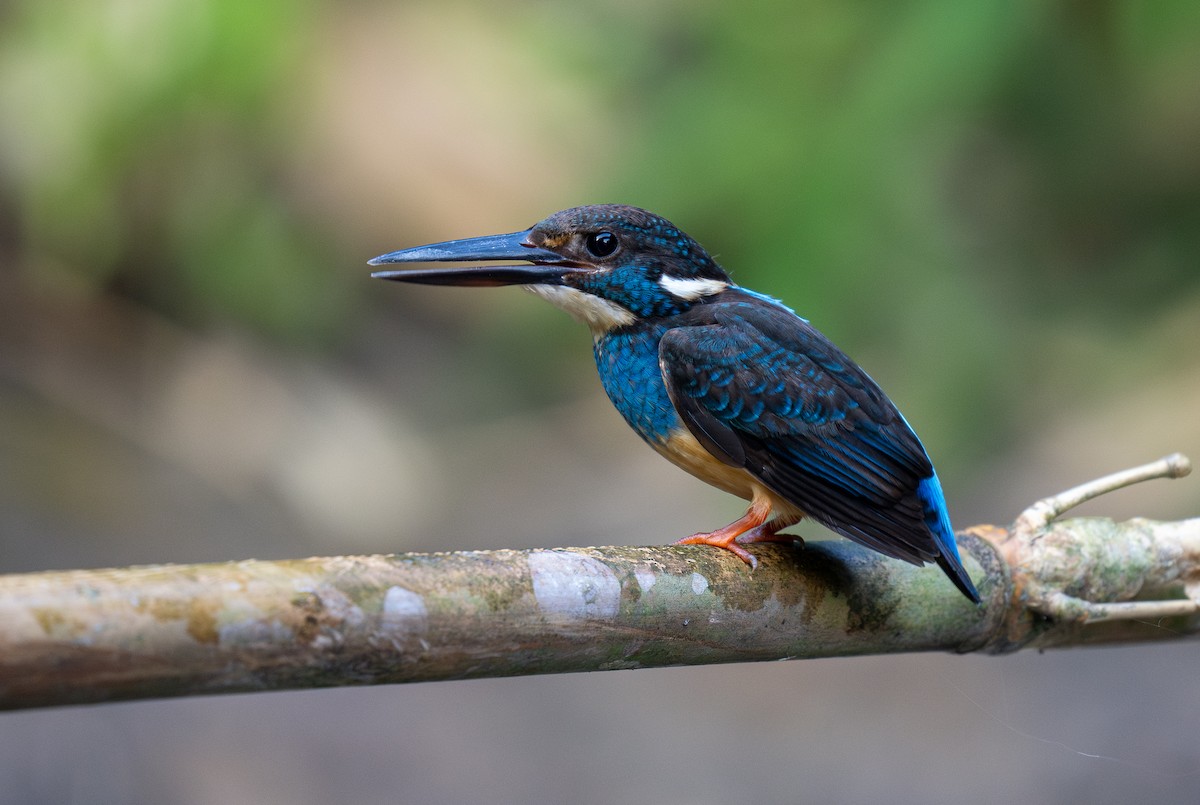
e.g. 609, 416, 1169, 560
371, 204, 731, 334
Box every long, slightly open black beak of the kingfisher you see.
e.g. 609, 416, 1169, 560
367, 229, 582, 286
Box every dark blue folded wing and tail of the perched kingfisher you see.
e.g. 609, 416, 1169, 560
659, 290, 978, 600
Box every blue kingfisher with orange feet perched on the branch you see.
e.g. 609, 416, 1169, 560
368, 204, 979, 603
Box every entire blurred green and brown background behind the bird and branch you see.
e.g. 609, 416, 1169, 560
0, 0, 1200, 804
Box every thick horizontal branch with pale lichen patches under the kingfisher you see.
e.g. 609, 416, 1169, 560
0, 456, 1200, 709
